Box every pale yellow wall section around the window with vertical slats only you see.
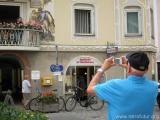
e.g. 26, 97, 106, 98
54, 0, 115, 45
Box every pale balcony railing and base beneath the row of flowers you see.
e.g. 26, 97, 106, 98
0, 28, 42, 51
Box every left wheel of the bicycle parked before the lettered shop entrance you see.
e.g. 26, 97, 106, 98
66, 96, 77, 112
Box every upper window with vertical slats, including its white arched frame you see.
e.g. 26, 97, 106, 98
74, 4, 95, 35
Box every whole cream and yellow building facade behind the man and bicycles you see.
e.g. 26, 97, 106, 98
0, 0, 156, 103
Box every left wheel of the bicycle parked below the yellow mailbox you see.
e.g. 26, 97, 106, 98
28, 98, 39, 111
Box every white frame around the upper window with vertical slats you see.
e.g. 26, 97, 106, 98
73, 3, 95, 36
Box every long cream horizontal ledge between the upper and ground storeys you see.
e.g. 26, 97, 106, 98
40, 45, 157, 52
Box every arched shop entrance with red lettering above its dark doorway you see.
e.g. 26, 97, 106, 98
63, 56, 101, 95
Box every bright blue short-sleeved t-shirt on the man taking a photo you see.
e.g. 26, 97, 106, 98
94, 76, 158, 120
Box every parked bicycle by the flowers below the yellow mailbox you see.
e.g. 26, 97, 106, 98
28, 89, 65, 113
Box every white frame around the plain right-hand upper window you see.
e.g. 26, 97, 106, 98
124, 8, 142, 37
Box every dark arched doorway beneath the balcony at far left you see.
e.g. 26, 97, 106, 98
0, 55, 22, 103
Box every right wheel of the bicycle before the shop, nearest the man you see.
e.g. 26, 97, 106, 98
89, 96, 104, 111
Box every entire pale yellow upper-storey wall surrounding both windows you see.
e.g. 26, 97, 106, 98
54, 0, 154, 46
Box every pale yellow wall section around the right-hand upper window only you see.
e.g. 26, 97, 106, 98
120, 0, 154, 45
